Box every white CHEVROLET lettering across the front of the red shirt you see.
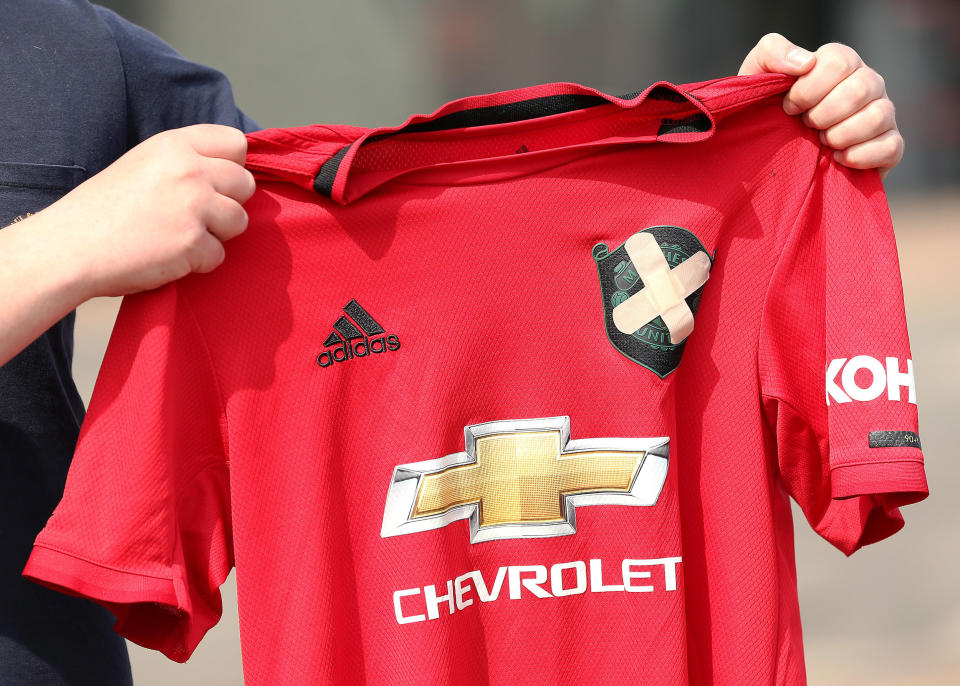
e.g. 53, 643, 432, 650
393, 557, 681, 624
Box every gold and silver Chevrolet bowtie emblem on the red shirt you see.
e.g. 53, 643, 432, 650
380, 417, 669, 543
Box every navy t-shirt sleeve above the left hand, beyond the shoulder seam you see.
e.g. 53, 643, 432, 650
96, 7, 259, 140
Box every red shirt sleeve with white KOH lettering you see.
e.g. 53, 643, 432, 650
758, 149, 927, 555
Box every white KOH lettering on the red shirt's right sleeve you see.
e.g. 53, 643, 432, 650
826, 355, 917, 405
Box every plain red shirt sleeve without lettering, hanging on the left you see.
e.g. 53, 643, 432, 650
24, 284, 233, 662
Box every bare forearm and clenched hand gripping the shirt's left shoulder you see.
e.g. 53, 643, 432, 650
0, 124, 255, 364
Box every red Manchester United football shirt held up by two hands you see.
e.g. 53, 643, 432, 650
25, 76, 927, 685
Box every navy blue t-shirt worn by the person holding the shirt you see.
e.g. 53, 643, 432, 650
0, 0, 256, 686
